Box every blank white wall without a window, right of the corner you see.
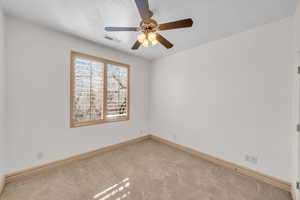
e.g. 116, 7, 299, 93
150, 18, 292, 181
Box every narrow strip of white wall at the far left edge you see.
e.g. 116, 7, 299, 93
0, 1, 7, 193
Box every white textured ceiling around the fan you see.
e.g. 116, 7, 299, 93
3, 0, 297, 59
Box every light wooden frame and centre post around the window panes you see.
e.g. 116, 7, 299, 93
70, 51, 130, 128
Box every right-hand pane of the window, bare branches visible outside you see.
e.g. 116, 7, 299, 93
106, 64, 128, 119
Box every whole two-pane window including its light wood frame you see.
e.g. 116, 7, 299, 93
70, 52, 129, 127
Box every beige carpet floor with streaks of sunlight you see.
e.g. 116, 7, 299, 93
0, 140, 291, 200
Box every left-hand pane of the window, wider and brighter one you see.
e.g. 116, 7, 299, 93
72, 57, 104, 122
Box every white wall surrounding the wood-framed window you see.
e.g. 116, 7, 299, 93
7, 18, 150, 173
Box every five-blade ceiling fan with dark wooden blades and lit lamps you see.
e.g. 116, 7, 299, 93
105, 0, 193, 50
